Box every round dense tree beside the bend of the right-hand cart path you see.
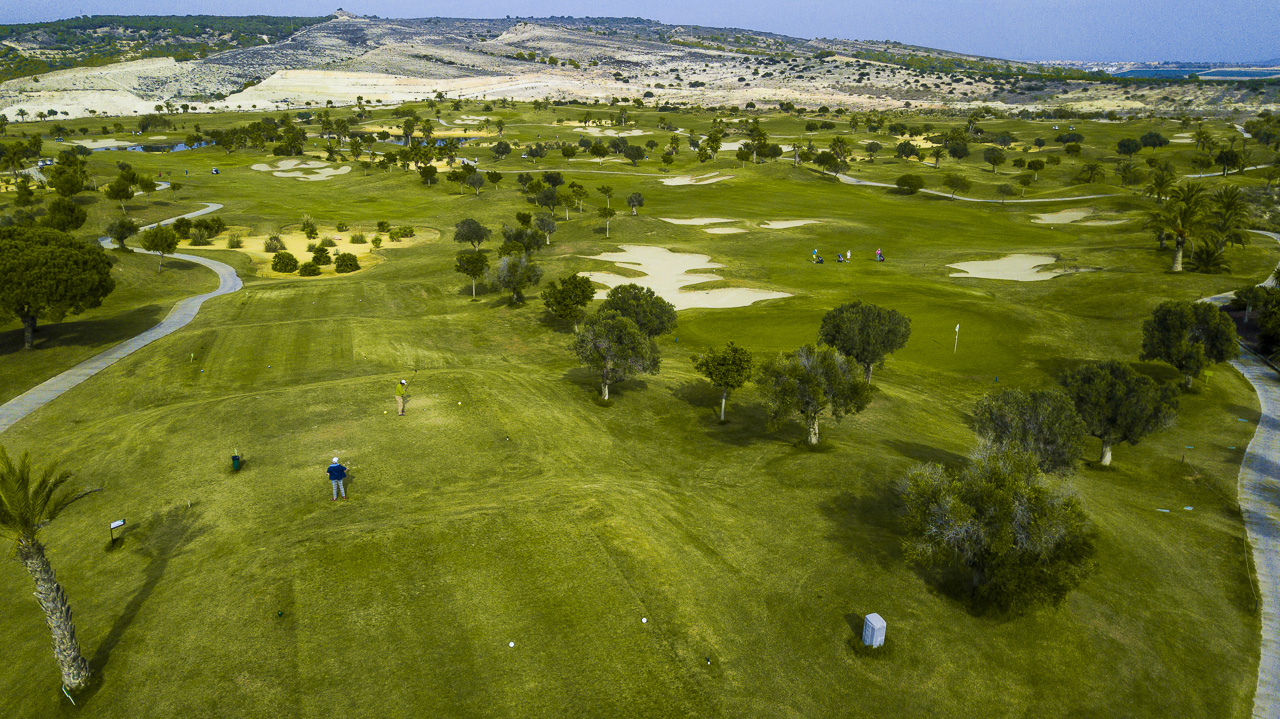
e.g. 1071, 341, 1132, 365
1138, 299, 1239, 389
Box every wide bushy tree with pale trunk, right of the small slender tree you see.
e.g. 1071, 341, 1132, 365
755, 344, 872, 445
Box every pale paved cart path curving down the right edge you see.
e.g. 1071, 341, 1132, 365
1206, 230, 1280, 719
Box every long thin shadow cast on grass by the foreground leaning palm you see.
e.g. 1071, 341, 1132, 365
81, 505, 207, 705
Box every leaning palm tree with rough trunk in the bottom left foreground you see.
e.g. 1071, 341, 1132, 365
0, 448, 97, 690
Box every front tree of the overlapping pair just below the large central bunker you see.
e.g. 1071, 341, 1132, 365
570, 307, 662, 399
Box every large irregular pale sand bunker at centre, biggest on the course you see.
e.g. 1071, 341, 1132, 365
582, 244, 791, 310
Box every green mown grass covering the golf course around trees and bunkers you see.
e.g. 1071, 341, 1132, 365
0, 104, 1280, 718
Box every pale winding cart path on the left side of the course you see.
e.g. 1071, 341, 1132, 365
0, 202, 242, 432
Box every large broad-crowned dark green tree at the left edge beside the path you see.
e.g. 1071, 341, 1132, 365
0, 228, 115, 349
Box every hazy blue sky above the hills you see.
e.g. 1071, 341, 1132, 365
0, 0, 1280, 61
